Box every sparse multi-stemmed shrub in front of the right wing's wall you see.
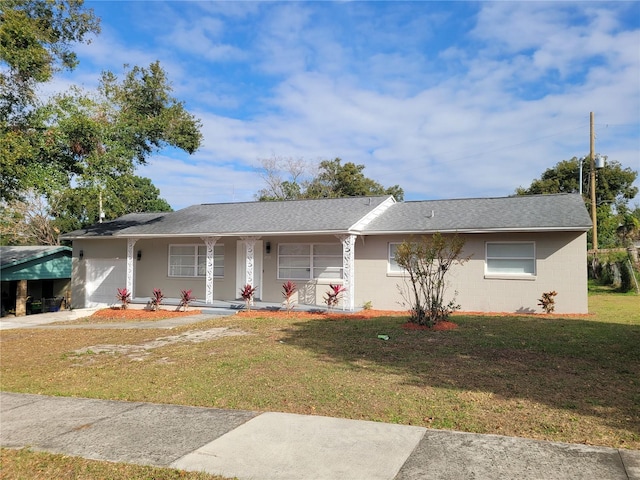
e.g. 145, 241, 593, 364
395, 232, 471, 327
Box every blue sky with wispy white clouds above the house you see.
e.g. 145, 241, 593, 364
57, 1, 640, 209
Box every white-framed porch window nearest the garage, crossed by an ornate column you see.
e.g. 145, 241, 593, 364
169, 244, 224, 278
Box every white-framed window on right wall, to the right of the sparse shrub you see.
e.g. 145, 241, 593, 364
485, 242, 536, 277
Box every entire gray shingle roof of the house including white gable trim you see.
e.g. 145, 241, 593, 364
62, 194, 591, 239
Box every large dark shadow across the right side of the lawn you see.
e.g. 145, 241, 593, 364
284, 317, 640, 434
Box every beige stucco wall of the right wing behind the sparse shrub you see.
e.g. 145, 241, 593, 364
355, 232, 588, 313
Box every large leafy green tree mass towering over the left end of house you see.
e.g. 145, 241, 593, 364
0, 0, 195, 242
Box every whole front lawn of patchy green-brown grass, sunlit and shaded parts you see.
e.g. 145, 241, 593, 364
0, 293, 640, 449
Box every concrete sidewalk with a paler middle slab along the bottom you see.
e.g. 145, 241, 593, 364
0, 392, 640, 480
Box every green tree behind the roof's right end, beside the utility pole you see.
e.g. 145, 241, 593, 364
516, 157, 638, 248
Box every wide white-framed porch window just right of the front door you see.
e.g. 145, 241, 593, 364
278, 243, 343, 280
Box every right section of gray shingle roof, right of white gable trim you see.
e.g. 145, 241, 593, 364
365, 194, 591, 234
